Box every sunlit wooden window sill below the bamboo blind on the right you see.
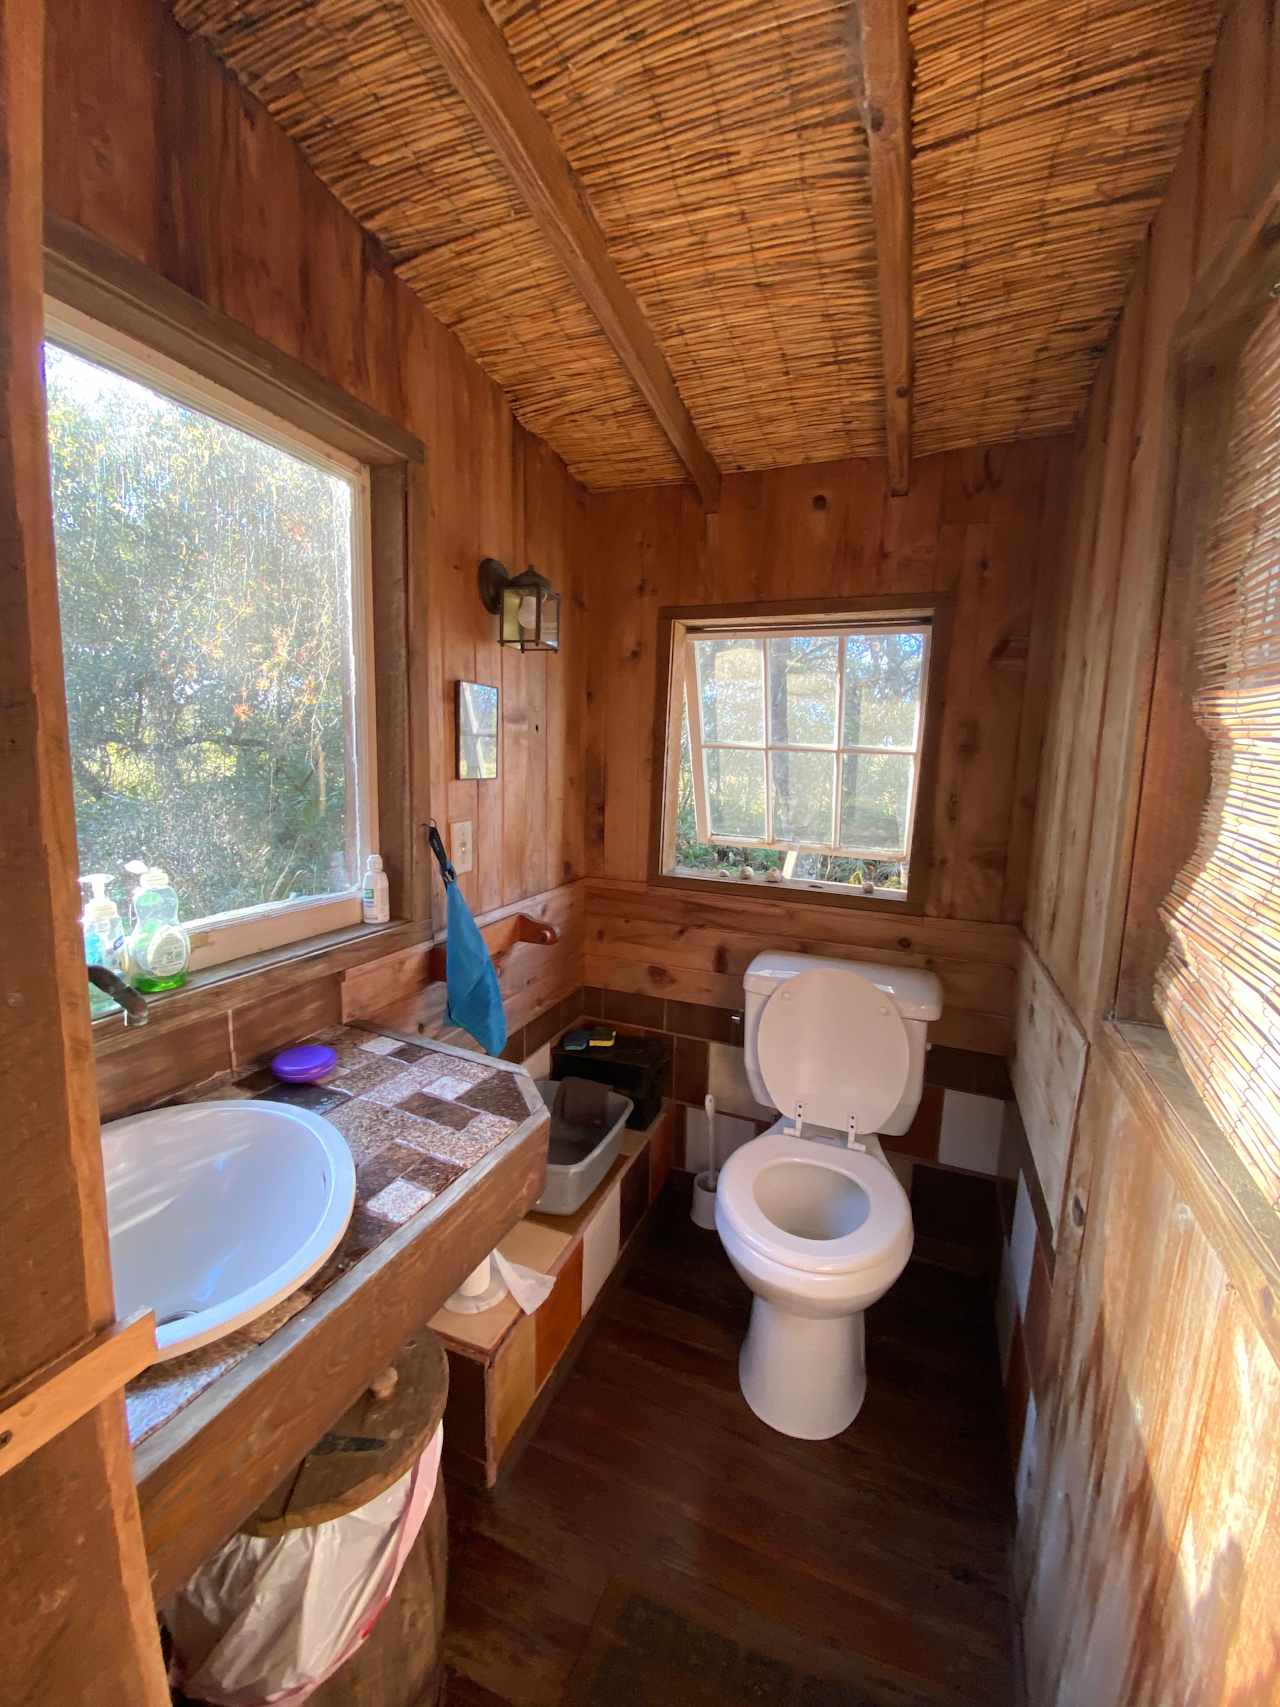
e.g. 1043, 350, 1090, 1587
1099, 1021, 1280, 1362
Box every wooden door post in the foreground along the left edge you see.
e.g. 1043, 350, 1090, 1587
0, 0, 169, 1679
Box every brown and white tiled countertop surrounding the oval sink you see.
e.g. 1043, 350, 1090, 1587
125, 1026, 543, 1446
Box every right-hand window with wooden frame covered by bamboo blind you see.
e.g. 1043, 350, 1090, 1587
1114, 163, 1280, 1242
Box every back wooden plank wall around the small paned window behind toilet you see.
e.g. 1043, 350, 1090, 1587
580, 439, 1072, 1053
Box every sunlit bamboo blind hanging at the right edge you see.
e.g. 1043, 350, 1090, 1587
1157, 307, 1280, 1205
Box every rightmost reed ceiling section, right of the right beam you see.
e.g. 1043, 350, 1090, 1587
910, 0, 1220, 454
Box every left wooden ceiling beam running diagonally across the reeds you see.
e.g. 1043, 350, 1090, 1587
406, 0, 720, 510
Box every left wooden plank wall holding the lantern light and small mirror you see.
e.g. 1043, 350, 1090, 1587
44, 0, 587, 1113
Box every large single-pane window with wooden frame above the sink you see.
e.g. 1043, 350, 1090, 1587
44, 218, 425, 996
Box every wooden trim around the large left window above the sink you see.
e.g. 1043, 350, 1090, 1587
44, 213, 432, 990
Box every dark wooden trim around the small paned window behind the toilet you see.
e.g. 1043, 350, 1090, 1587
649, 591, 952, 918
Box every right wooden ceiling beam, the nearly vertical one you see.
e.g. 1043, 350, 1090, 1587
857, 0, 915, 493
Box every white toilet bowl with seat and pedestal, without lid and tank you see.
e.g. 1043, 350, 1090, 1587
715, 1130, 911, 1441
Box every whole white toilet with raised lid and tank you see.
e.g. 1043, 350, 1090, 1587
715, 953, 942, 1441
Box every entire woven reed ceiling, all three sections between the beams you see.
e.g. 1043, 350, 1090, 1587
171, 0, 1220, 488
